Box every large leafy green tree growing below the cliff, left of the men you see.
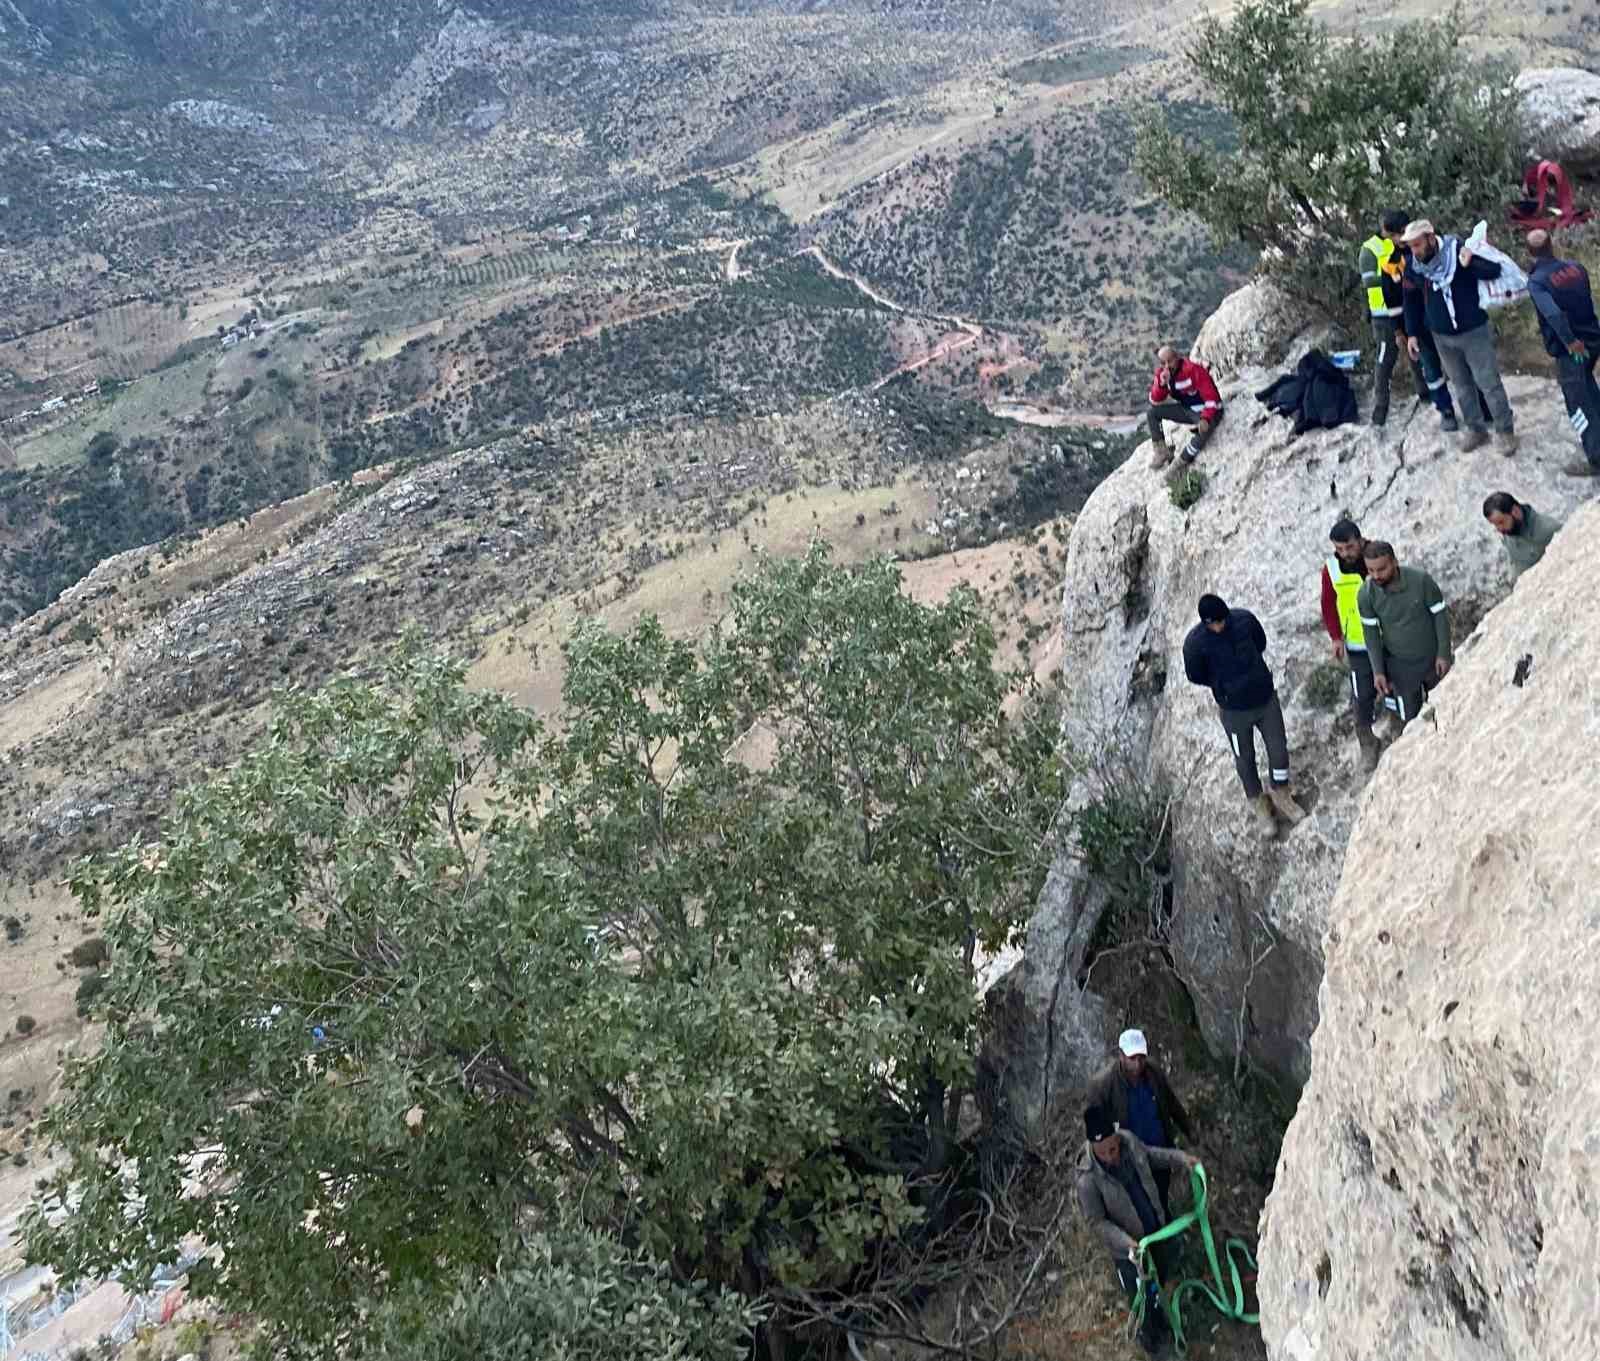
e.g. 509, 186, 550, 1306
27, 547, 1061, 1358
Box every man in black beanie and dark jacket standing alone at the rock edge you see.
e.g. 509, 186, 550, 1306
1184, 595, 1306, 833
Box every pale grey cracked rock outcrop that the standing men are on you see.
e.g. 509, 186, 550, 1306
990, 343, 1592, 1129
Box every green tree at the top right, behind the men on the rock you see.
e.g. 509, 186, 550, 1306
1134, 0, 1523, 310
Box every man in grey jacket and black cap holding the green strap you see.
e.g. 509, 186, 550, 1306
1078, 1105, 1200, 1356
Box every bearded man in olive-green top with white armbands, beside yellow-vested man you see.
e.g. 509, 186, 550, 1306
1355, 539, 1453, 728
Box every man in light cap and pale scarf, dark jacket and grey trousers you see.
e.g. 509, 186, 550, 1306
1402, 218, 1517, 456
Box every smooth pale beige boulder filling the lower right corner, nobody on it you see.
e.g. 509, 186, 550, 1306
1259, 504, 1600, 1361
